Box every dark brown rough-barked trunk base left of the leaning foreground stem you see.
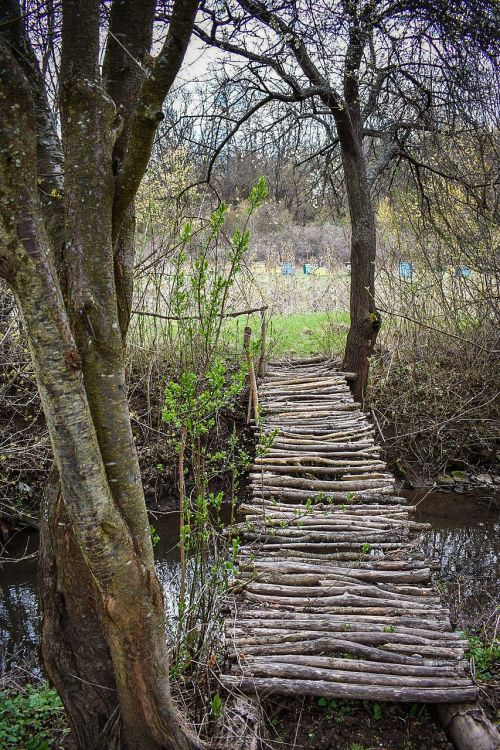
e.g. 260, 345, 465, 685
38, 469, 120, 748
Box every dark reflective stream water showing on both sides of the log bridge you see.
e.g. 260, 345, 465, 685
0, 490, 500, 675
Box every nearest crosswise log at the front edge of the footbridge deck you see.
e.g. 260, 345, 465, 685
221, 675, 479, 703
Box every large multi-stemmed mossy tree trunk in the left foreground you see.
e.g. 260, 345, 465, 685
0, 0, 197, 750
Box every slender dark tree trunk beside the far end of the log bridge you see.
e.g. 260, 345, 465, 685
342, 136, 381, 403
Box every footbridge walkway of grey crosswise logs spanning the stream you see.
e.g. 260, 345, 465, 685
222, 360, 478, 703
